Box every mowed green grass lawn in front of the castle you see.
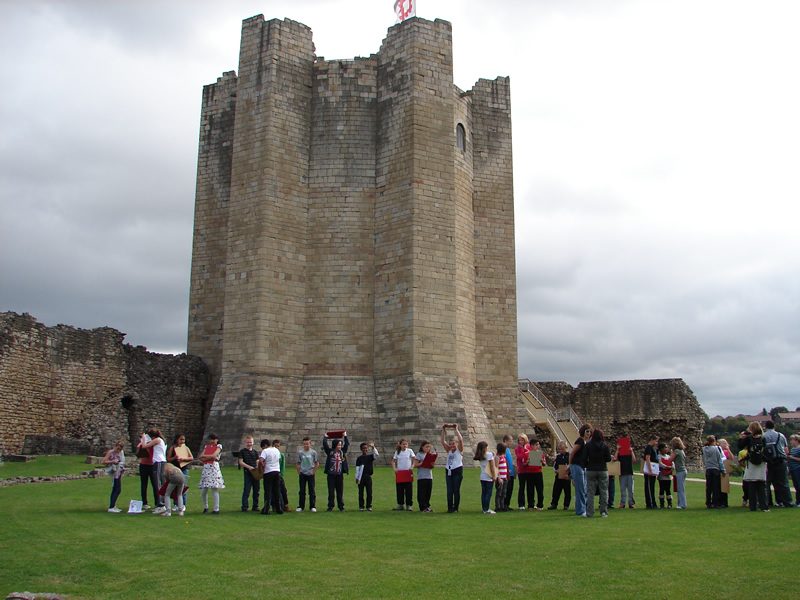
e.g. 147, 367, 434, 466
0, 457, 800, 600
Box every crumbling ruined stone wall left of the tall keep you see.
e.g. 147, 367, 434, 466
0, 312, 209, 454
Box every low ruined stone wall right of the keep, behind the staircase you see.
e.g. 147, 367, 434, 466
536, 379, 706, 463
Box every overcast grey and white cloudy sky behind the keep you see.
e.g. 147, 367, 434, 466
0, 0, 800, 416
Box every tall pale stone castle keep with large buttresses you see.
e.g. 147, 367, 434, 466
188, 15, 530, 460
